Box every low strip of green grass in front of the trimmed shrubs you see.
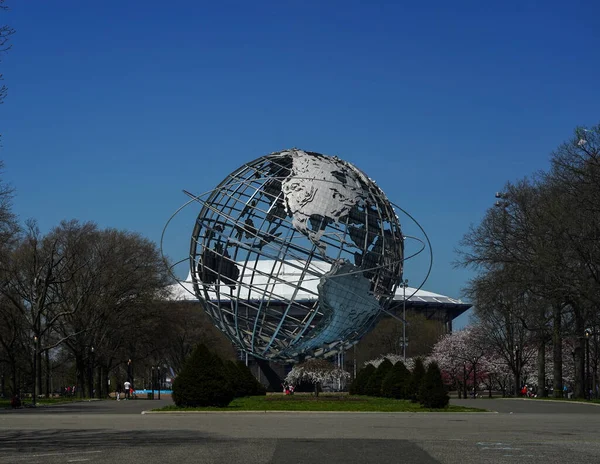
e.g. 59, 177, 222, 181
153, 394, 485, 412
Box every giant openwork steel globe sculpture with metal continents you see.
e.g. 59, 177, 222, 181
190, 149, 404, 362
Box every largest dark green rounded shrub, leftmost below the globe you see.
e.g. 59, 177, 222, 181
173, 345, 234, 407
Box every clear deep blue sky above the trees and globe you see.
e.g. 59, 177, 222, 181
0, 0, 600, 326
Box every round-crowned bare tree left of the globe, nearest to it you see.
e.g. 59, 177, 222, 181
52, 222, 170, 394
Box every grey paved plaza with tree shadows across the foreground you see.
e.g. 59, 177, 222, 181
0, 398, 600, 464
